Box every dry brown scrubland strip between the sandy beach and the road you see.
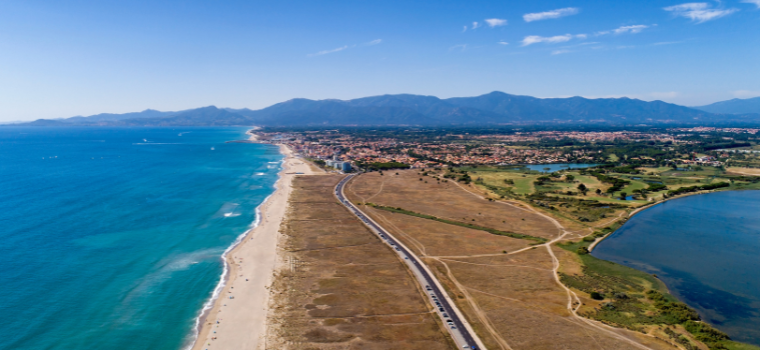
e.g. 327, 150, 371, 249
266, 175, 454, 350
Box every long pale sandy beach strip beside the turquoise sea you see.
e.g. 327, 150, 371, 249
192, 145, 314, 350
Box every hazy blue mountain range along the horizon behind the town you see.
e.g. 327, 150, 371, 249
10, 91, 760, 126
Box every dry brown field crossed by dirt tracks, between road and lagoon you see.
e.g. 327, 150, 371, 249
346, 170, 674, 350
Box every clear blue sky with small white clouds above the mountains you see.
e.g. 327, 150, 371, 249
0, 0, 760, 121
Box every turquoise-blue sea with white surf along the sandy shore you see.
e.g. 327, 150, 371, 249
0, 127, 282, 350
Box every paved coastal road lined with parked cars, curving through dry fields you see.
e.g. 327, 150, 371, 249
335, 175, 485, 349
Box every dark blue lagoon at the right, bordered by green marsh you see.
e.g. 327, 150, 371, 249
592, 191, 760, 345
